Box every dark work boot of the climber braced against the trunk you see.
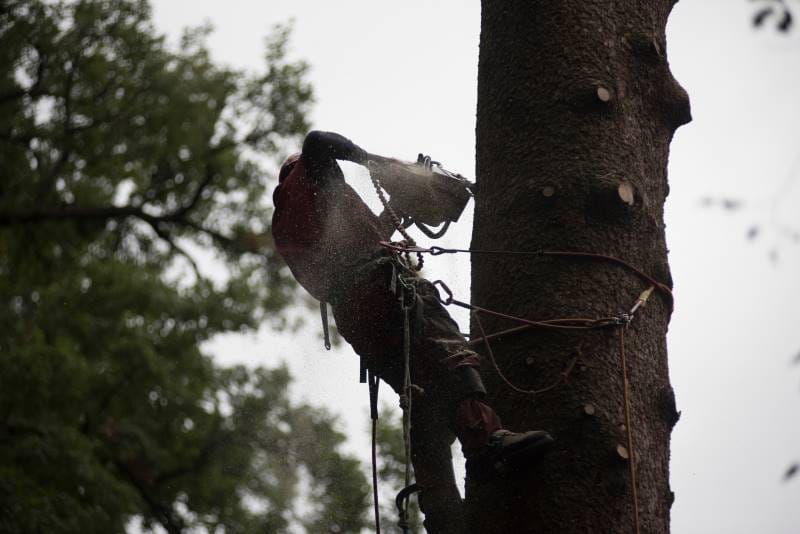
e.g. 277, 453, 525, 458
467, 429, 554, 481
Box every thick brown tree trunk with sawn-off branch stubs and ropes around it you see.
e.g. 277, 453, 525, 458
467, 0, 690, 534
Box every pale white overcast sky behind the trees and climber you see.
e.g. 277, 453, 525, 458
153, 0, 800, 534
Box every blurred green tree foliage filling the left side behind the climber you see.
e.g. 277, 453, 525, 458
0, 0, 368, 533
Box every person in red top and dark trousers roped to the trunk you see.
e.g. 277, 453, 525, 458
272, 131, 552, 531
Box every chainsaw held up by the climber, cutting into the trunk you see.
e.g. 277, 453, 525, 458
368, 154, 475, 239
